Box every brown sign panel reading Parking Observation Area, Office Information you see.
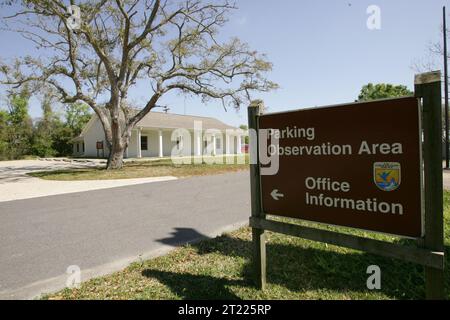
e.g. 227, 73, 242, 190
259, 98, 423, 237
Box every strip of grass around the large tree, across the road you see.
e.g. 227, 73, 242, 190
29, 155, 249, 181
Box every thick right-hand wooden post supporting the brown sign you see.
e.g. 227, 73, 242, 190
414, 71, 444, 299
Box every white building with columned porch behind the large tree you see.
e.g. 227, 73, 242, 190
72, 112, 247, 158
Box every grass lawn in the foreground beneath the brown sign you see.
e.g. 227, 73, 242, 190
44, 192, 450, 300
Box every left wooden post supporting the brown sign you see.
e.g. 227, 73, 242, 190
247, 101, 266, 290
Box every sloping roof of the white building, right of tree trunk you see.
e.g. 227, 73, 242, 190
136, 111, 236, 130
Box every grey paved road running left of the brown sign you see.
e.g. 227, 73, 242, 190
0, 171, 250, 299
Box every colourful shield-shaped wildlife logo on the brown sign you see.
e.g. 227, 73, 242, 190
373, 162, 401, 191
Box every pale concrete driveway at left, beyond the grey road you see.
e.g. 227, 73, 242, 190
0, 159, 176, 202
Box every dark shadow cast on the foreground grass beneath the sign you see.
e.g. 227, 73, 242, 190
146, 228, 450, 299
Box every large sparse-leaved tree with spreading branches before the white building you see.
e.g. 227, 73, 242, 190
0, 0, 277, 169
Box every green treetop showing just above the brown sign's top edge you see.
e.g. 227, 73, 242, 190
358, 83, 414, 101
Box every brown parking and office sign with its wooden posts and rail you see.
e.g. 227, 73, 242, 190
248, 72, 444, 299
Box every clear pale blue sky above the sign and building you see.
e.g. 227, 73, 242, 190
0, 0, 450, 126
